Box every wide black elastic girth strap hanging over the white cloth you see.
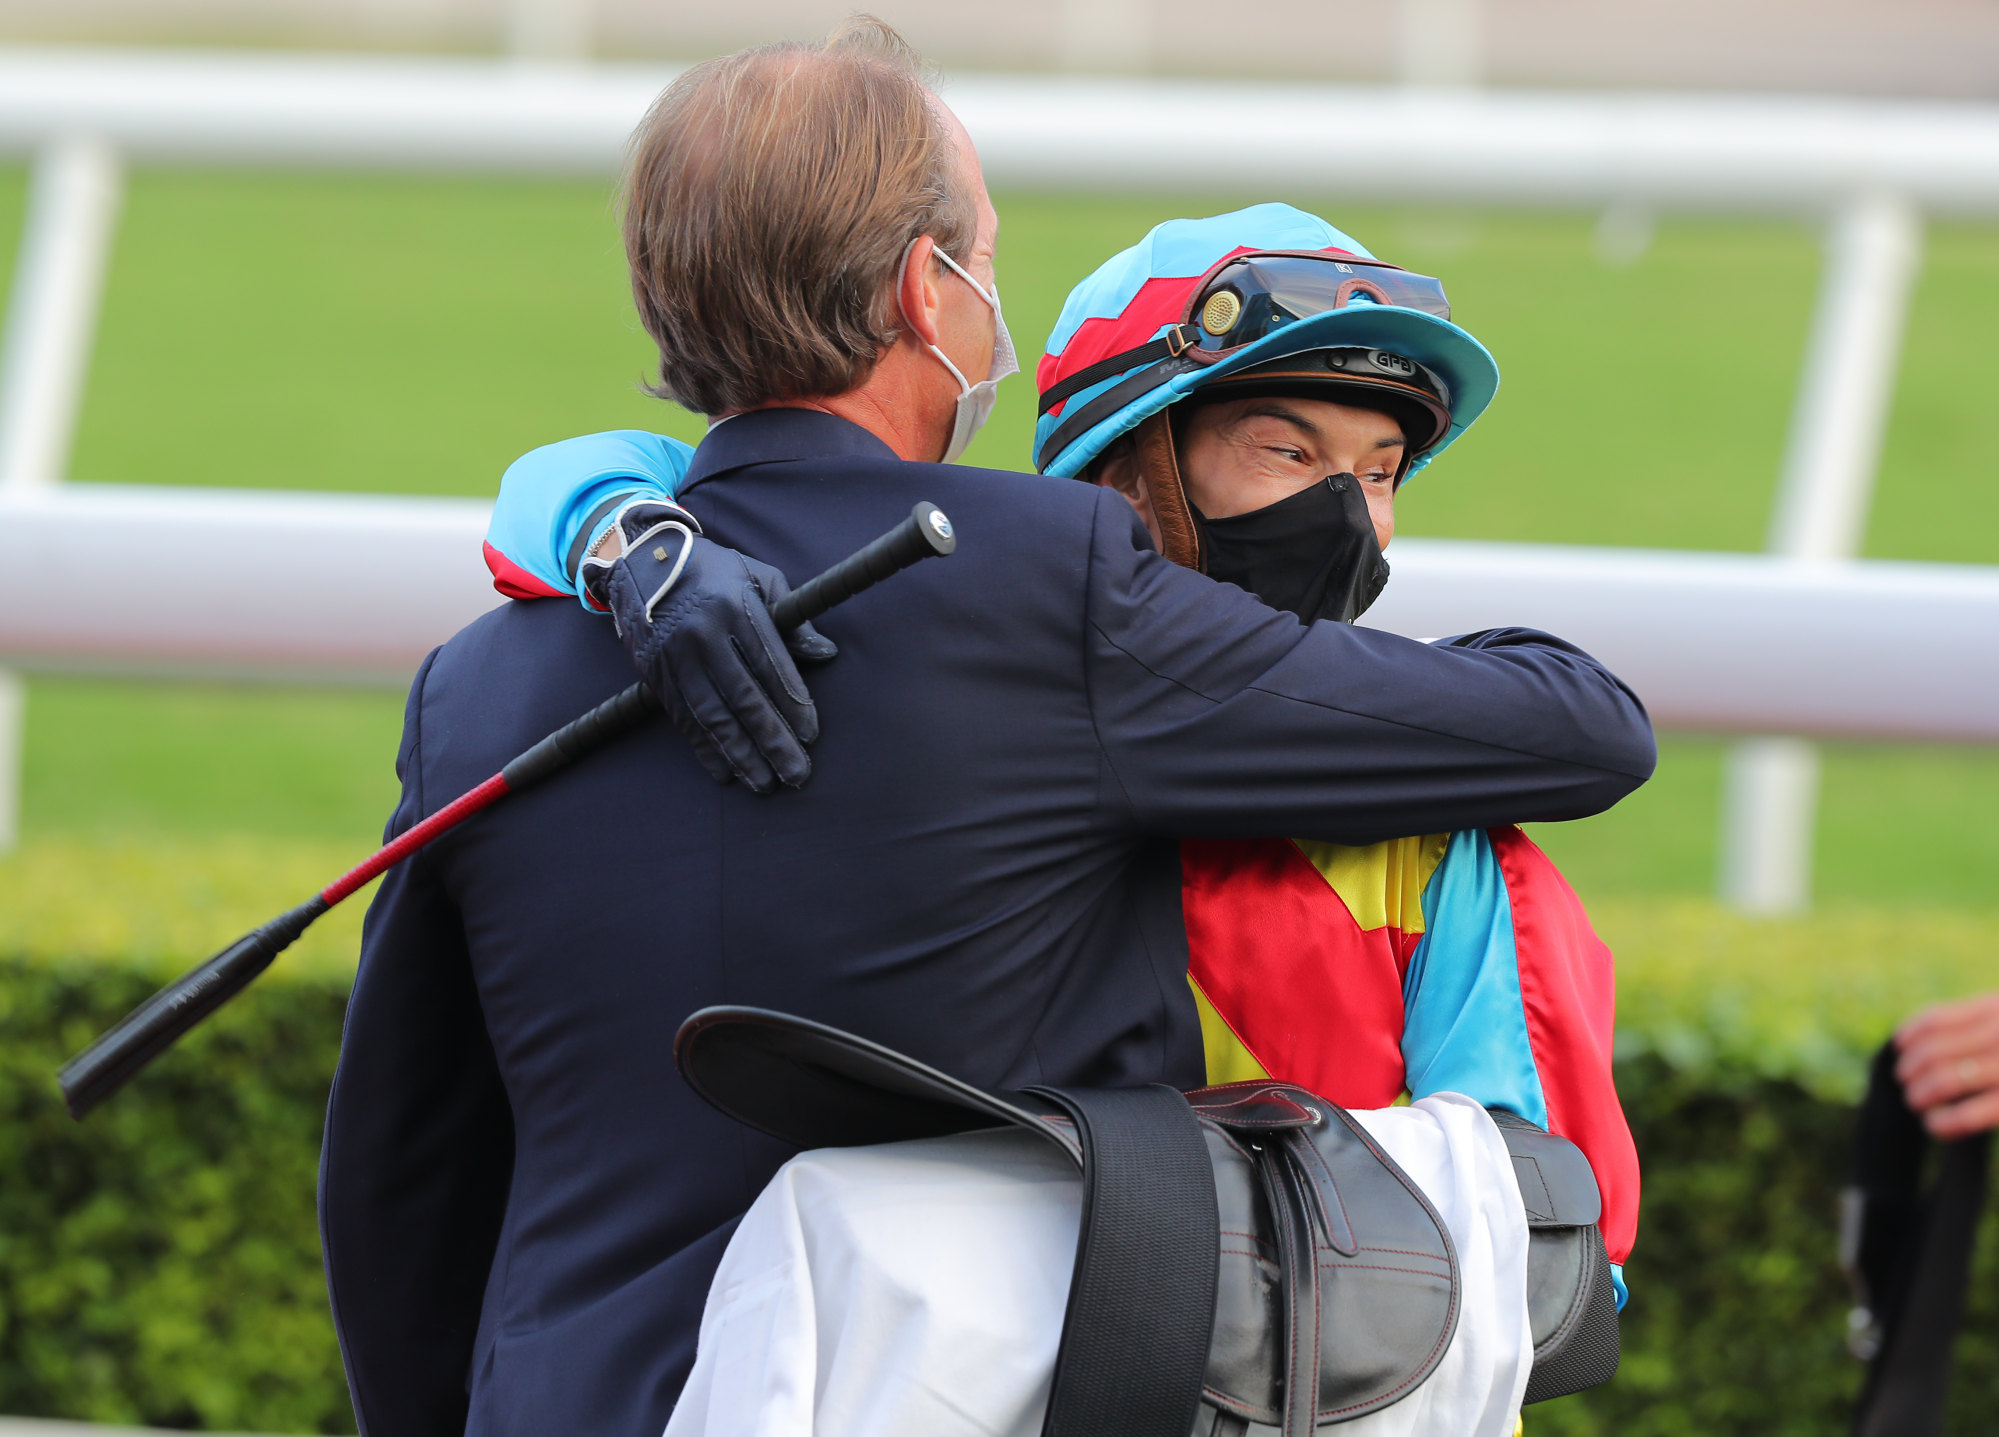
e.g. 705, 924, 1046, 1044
1027, 1085, 1221, 1437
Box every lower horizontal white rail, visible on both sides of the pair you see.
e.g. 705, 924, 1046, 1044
0, 484, 1999, 743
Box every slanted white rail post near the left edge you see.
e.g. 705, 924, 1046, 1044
0, 136, 124, 853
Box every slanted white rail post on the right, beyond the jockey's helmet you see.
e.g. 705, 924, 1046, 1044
1721, 192, 1923, 913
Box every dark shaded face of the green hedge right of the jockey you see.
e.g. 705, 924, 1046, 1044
1527, 1055, 1999, 1437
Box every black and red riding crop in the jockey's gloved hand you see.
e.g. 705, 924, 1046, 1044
56, 504, 958, 1119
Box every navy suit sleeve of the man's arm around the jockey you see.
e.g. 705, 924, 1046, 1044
1085, 490, 1657, 843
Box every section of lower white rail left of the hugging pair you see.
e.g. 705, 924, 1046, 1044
0, 484, 500, 688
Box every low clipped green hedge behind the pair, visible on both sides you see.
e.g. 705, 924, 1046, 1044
0, 903, 1999, 1437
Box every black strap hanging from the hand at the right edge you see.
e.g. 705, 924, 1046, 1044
1853, 1043, 1991, 1437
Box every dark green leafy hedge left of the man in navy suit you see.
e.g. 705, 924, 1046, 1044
0, 961, 354, 1433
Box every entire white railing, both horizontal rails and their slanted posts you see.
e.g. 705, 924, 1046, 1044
0, 50, 1999, 911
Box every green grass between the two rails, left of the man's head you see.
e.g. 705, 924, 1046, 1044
72, 172, 679, 496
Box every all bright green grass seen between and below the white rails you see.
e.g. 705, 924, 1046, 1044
11, 172, 1999, 905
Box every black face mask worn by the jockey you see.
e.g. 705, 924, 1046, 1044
1193, 474, 1387, 624
